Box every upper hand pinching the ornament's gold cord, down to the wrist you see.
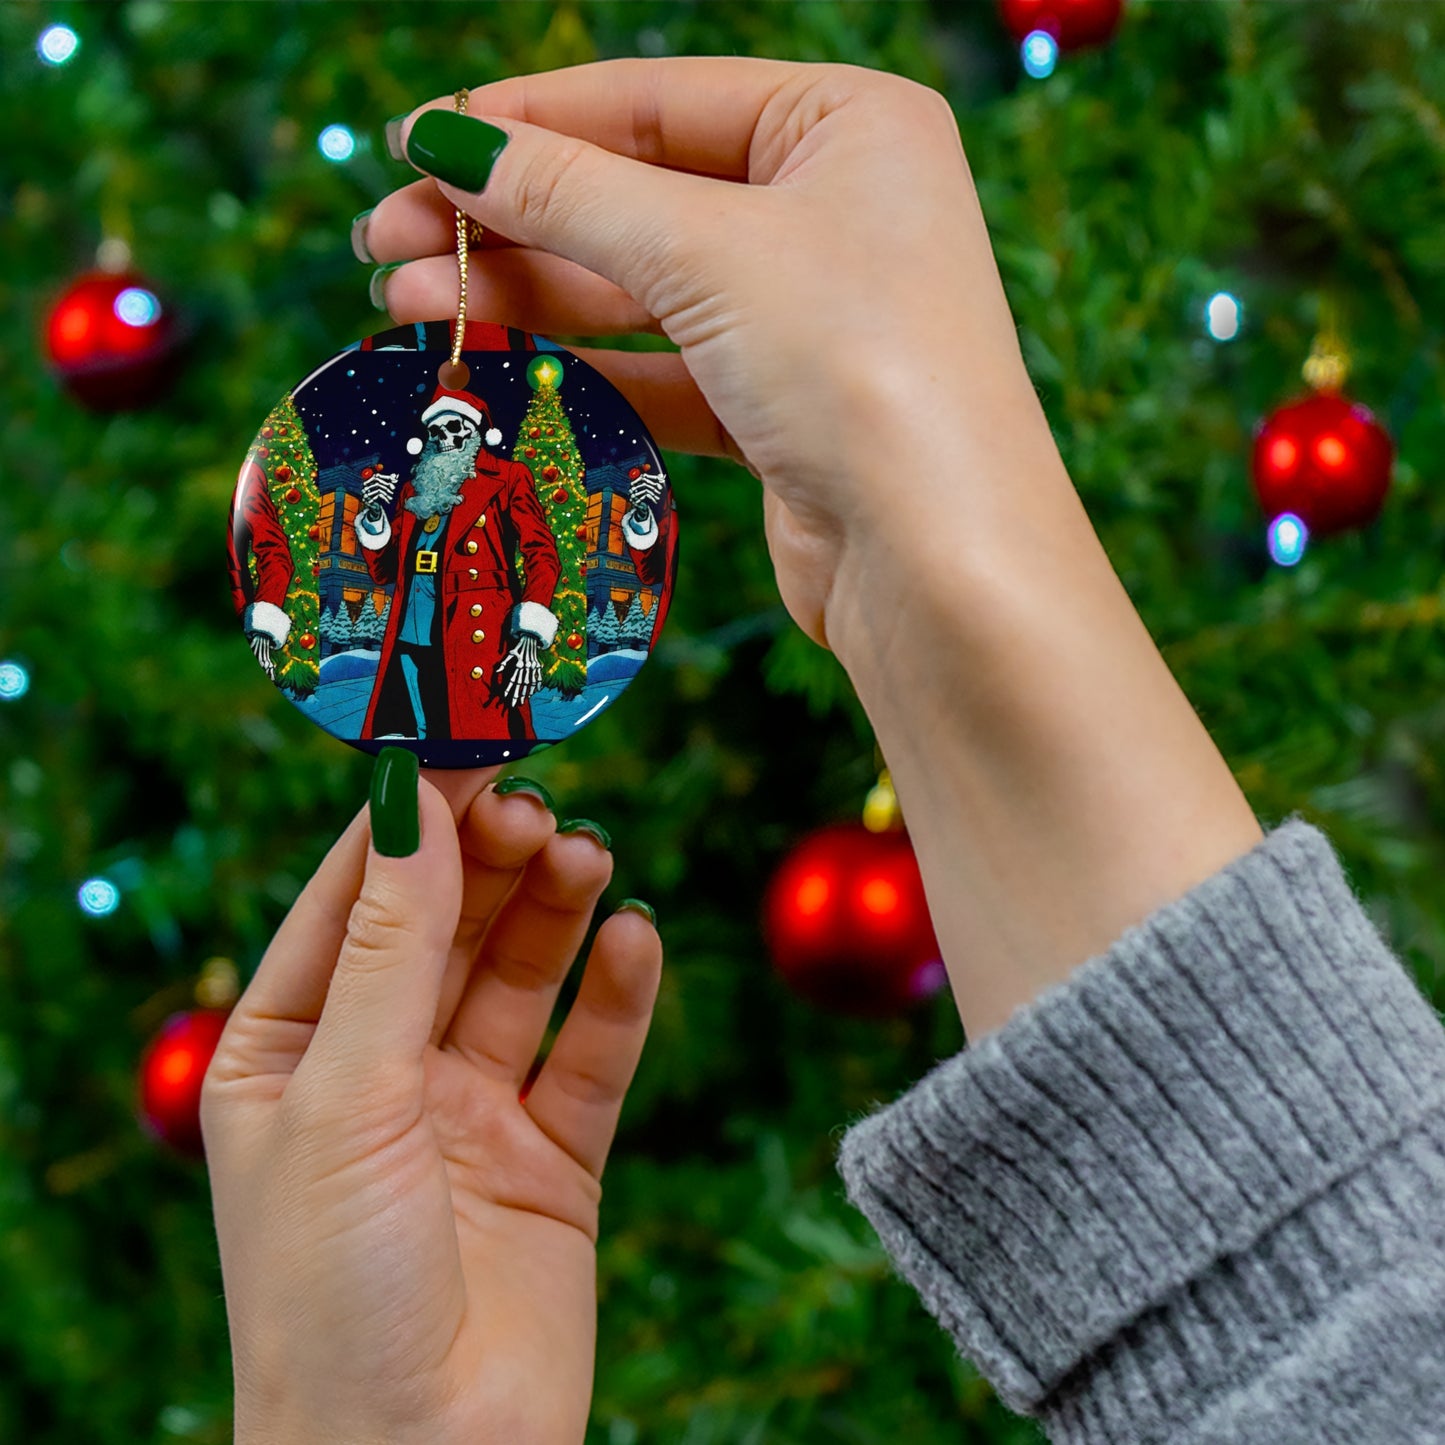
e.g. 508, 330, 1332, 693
356, 56, 1058, 663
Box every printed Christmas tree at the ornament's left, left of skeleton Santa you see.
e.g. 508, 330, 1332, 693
247, 394, 321, 698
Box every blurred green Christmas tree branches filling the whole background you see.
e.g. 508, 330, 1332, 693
0, 0, 1445, 1445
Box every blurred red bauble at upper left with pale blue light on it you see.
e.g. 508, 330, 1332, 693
45, 272, 178, 412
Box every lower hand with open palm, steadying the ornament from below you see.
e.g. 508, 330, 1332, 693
201, 754, 662, 1445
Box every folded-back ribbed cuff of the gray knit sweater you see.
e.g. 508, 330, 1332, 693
840, 816, 1445, 1438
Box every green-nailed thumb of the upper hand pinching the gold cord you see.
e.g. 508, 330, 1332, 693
400, 107, 722, 305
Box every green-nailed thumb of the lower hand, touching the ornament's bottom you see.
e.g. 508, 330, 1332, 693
298, 747, 461, 1084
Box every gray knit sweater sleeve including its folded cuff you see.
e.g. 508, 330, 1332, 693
840, 815, 1445, 1445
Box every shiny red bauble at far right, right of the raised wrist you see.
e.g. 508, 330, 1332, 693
1251, 392, 1394, 536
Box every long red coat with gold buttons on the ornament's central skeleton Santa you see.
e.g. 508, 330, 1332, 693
361, 448, 562, 741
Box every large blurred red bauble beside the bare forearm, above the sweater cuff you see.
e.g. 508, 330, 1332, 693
763, 824, 945, 1016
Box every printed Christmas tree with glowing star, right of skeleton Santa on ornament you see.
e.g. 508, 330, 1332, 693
512, 353, 587, 698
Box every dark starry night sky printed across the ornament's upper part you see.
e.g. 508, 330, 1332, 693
296, 339, 662, 477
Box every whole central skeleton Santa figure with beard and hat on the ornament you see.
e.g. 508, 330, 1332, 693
355, 387, 561, 740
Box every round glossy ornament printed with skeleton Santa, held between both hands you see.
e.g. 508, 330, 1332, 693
228, 321, 678, 767
